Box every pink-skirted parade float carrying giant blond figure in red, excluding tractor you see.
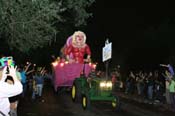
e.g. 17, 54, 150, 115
52, 31, 96, 93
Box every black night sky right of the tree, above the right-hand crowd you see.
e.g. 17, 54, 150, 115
83, 0, 175, 70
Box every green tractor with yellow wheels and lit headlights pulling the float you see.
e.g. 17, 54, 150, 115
71, 75, 120, 111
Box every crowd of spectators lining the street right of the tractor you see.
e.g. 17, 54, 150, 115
111, 64, 175, 111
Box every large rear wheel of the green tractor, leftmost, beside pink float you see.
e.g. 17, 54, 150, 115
71, 83, 80, 102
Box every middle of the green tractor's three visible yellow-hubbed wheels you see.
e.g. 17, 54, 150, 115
81, 95, 90, 110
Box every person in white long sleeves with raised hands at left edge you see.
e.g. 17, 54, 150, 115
0, 66, 22, 116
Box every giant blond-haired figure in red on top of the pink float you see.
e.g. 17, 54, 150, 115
64, 31, 91, 63
